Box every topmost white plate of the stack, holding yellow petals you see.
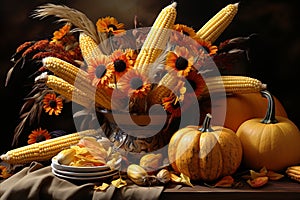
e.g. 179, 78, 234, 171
51, 156, 122, 172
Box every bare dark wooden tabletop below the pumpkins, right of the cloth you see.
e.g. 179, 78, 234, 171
161, 178, 300, 200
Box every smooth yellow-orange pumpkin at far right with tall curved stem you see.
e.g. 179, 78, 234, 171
236, 90, 300, 171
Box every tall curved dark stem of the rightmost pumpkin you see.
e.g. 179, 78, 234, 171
260, 90, 278, 124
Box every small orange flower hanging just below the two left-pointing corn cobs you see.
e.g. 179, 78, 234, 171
43, 93, 63, 115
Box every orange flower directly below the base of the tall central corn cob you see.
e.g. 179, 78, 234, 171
116, 69, 151, 98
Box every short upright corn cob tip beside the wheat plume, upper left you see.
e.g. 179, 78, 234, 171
79, 32, 103, 65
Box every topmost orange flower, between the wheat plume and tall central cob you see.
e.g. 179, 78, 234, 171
96, 16, 125, 36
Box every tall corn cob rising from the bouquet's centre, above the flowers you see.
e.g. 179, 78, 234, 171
134, 2, 177, 76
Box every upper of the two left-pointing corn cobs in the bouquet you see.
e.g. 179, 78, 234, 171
43, 57, 111, 109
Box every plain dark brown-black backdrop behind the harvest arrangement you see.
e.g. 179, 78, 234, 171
0, 0, 300, 153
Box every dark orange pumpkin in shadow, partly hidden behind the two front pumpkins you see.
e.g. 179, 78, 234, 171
200, 92, 287, 132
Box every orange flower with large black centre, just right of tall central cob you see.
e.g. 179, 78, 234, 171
166, 46, 194, 77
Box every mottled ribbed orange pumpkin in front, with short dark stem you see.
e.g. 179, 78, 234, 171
168, 114, 242, 181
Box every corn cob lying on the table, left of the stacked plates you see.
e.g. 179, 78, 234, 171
0, 129, 97, 164
